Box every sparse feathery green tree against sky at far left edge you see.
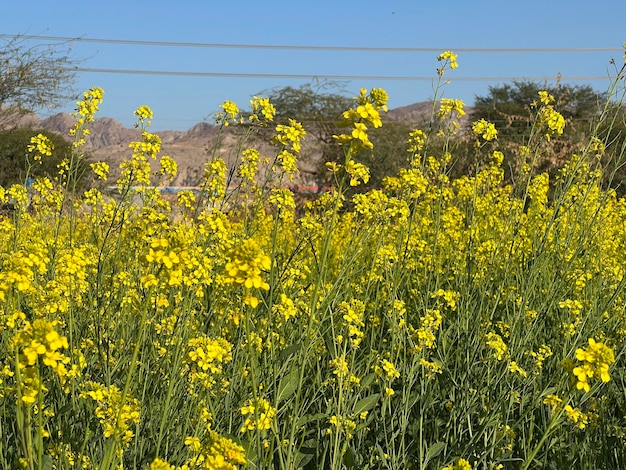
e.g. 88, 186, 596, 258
0, 36, 78, 129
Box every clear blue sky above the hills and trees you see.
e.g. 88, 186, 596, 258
0, 0, 626, 130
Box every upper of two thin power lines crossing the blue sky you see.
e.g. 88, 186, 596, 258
0, 34, 623, 53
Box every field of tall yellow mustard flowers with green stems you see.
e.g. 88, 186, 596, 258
0, 51, 626, 470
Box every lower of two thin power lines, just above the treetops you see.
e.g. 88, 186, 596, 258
67, 67, 611, 82
